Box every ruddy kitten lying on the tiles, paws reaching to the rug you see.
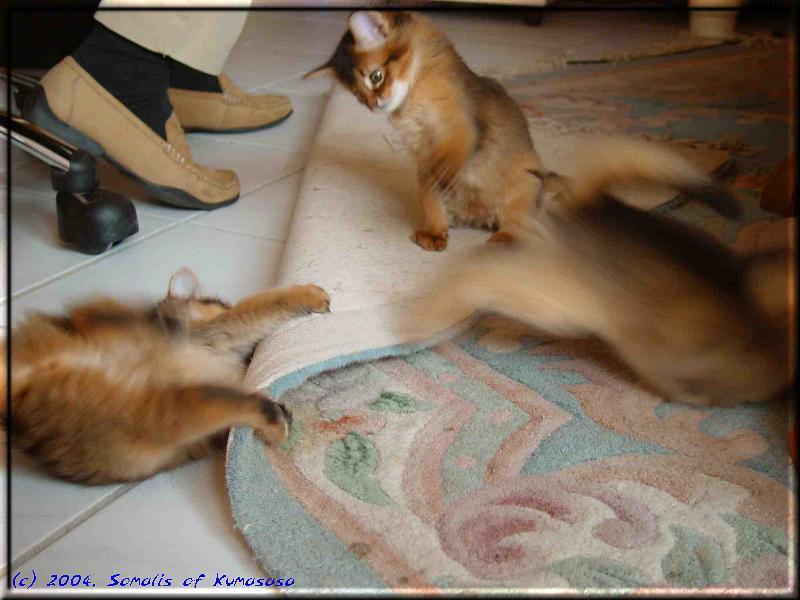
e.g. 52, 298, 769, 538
0, 269, 329, 484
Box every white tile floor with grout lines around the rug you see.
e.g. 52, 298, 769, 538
0, 11, 764, 583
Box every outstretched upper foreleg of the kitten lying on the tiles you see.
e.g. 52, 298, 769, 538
192, 285, 330, 350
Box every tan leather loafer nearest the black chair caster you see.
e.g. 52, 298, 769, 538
23, 56, 239, 210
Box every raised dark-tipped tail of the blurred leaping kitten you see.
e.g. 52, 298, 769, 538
548, 138, 740, 218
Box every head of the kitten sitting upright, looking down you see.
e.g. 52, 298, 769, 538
309, 12, 413, 114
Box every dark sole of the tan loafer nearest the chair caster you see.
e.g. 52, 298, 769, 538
22, 86, 239, 210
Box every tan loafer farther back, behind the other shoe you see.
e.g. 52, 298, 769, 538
169, 74, 292, 133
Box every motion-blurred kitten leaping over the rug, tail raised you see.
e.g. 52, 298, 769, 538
423, 141, 794, 406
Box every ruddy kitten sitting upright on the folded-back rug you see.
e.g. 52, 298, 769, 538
306, 11, 541, 250
